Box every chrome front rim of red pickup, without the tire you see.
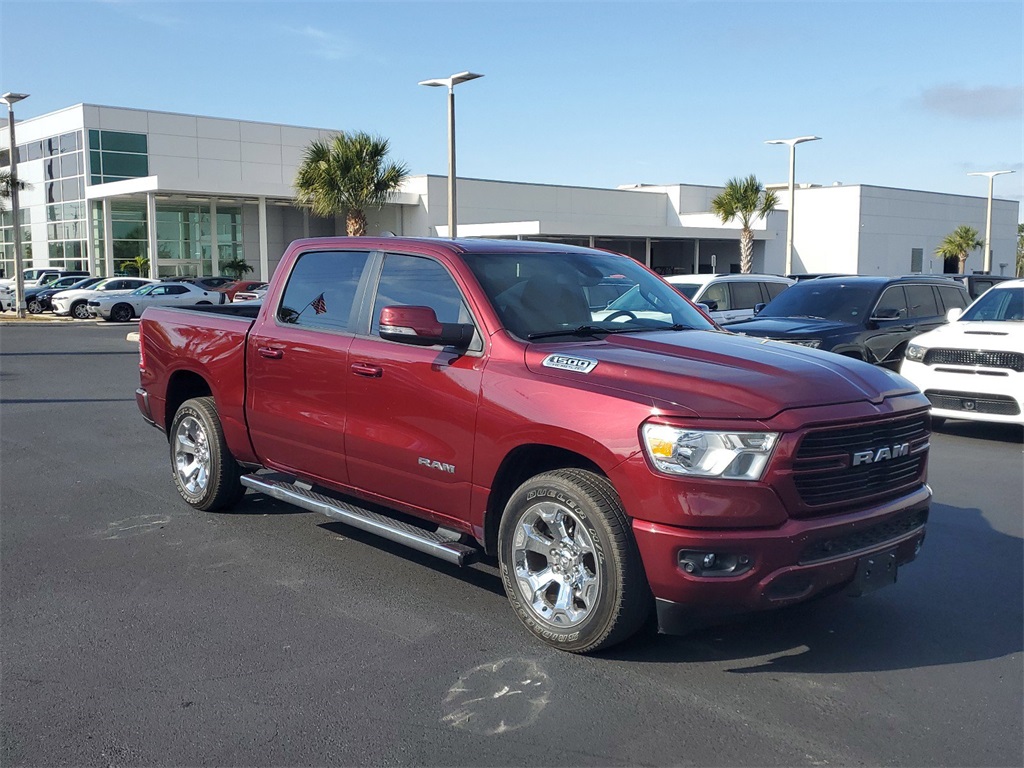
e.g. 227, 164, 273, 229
513, 501, 601, 630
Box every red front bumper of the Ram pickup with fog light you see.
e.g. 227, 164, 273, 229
633, 485, 931, 632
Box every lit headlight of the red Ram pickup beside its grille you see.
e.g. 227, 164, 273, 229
643, 424, 778, 480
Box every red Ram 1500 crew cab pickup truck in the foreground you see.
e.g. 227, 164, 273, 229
136, 238, 931, 652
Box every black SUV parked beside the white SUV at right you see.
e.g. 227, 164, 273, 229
726, 275, 971, 371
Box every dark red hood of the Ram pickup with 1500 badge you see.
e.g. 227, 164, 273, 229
526, 331, 918, 420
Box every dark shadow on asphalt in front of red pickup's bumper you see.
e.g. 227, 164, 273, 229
603, 504, 1024, 674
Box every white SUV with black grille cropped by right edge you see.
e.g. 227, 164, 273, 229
900, 280, 1024, 424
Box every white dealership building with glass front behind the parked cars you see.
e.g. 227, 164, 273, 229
0, 104, 1019, 279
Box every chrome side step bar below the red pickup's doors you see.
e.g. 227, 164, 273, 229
242, 474, 480, 565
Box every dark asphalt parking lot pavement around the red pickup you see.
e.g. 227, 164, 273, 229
0, 323, 1024, 767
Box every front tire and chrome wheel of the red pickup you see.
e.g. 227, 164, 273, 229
498, 469, 652, 653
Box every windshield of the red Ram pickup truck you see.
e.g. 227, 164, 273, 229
466, 251, 715, 341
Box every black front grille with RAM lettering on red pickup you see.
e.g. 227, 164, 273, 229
794, 413, 929, 511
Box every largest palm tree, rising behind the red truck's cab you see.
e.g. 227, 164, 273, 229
295, 131, 409, 237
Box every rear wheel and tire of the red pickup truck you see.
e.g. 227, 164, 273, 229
170, 397, 246, 511
